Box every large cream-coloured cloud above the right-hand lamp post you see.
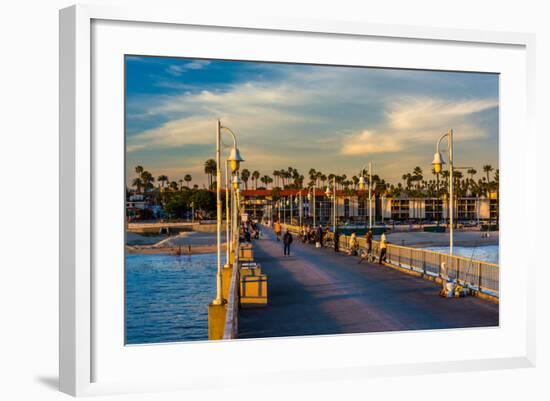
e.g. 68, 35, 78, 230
341, 97, 498, 155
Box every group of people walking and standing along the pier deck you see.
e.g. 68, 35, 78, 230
273, 221, 387, 264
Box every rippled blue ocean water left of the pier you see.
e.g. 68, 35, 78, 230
125, 254, 217, 344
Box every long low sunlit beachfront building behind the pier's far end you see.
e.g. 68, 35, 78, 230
242, 189, 498, 225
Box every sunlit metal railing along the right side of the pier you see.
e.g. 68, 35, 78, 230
284, 225, 499, 298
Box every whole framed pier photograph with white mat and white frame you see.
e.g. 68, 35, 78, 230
60, 6, 535, 395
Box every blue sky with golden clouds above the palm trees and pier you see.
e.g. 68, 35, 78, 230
125, 56, 498, 187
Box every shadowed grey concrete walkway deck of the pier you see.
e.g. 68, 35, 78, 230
239, 229, 499, 338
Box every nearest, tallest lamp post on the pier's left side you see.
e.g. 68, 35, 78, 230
212, 120, 244, 305
